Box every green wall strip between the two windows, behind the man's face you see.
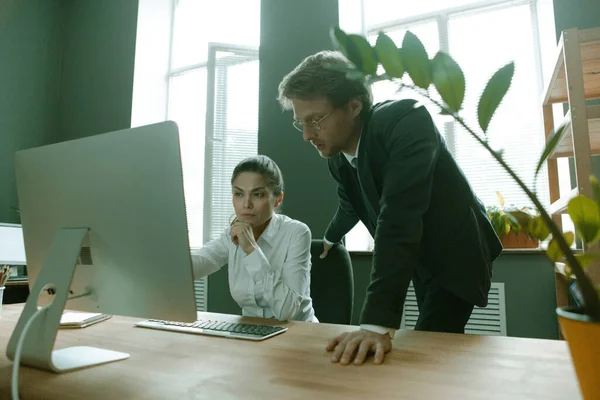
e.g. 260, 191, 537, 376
258, 0, 338, 238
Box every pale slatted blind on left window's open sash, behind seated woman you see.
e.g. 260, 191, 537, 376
204, 48, 258, 241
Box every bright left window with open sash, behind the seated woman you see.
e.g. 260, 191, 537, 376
168, 0, 260, 247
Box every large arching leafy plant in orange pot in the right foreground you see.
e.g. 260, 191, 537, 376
331, 28, 600, 399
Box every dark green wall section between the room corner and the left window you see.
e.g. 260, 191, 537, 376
59, 0, 138, 140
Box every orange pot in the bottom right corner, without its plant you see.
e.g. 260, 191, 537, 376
556, 308, 600, 400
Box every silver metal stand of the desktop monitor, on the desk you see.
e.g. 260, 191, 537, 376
6, 228, 129, 372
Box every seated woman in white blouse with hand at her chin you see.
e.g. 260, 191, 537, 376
192, 155, 318, 322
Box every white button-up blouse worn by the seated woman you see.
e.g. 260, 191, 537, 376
191, 214, 318, 322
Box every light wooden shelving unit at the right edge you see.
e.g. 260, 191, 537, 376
542, 27, 600, 320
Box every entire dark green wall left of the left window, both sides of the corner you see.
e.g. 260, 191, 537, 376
0, 0, 138, 222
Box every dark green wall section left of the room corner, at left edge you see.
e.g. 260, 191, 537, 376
0, 0, 62, 222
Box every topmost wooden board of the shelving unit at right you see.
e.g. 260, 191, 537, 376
542, 27, 600, 104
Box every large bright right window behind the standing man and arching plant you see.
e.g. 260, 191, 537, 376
340, 0, 555, 250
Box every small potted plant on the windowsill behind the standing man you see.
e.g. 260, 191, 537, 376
486, 192, 540, 249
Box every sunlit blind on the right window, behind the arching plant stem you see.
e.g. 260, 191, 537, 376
448, 4, 549, 207
